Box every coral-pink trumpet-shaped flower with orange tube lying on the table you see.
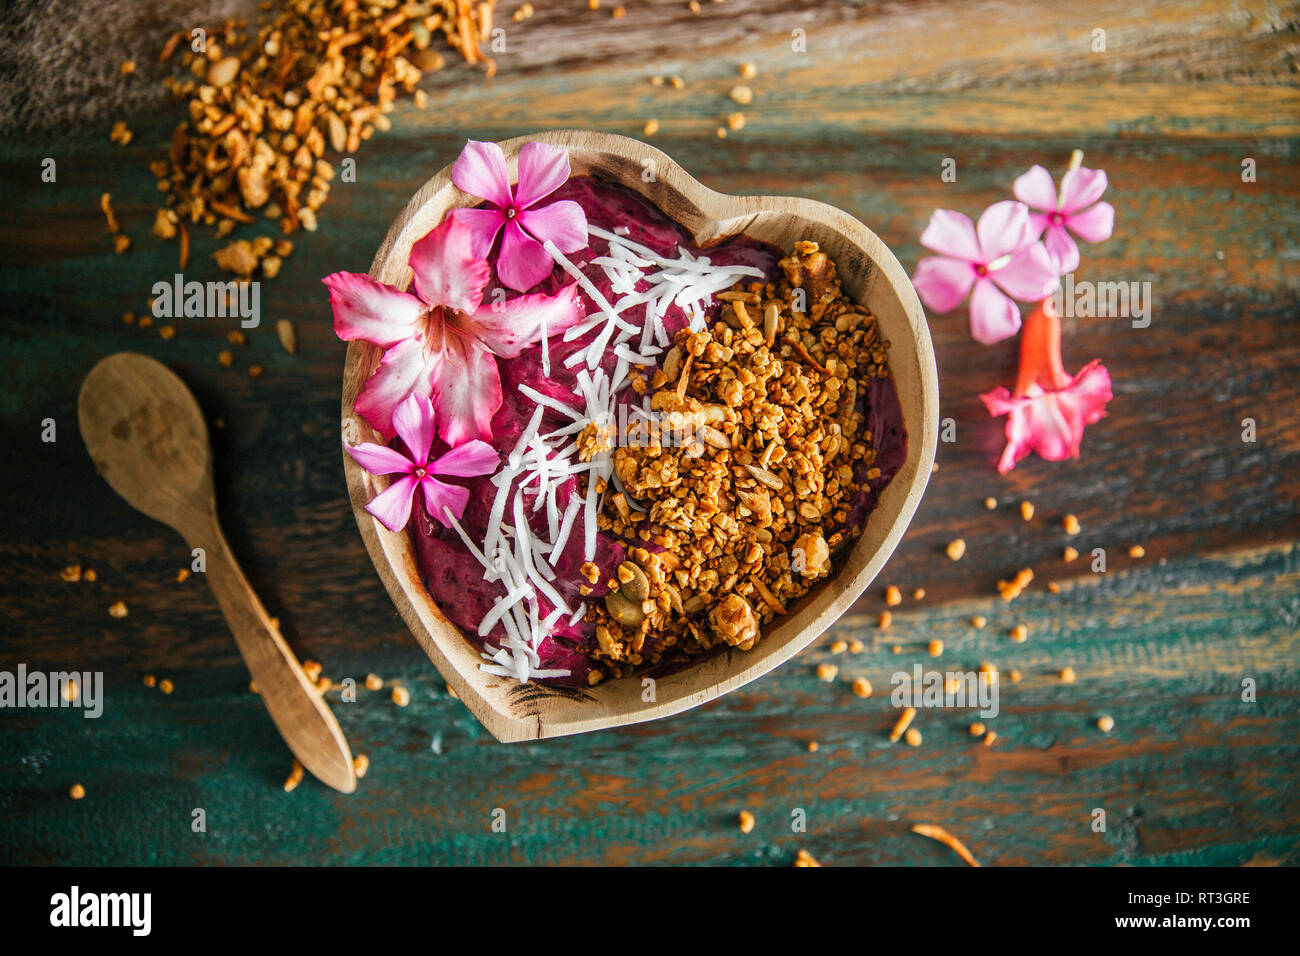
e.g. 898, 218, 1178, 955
980, 299, 1112, 475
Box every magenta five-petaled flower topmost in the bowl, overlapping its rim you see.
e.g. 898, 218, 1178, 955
451, 139, 586, 291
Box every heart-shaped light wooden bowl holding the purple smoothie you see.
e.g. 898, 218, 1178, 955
343, 130, 939, 741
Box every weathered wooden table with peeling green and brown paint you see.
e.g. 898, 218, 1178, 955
0, 0, 1300, 865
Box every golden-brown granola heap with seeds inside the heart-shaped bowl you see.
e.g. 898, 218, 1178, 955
584, 242, 889, 683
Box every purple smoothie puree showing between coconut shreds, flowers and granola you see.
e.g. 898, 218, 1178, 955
411, 177, 907, 687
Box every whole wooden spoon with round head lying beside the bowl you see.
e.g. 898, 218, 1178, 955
78, 352, 356, 793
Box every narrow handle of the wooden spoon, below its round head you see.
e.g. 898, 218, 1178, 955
187, 522, 356, 793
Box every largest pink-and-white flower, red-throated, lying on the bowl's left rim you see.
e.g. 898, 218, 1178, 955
324, 209, 584, 445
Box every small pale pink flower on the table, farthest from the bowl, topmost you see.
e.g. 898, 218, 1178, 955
1015, 151, 1115, 276
